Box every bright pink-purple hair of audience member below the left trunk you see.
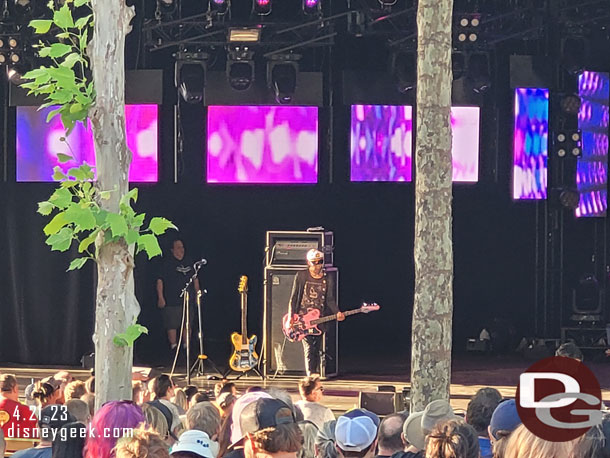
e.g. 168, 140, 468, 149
84, 401, 146, 458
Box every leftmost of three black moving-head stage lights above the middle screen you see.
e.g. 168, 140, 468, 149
174, 51, 208, 104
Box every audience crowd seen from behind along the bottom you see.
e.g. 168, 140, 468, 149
0, 345, 610, 458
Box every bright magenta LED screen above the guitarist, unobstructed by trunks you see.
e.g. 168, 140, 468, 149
207, 106, 318, 184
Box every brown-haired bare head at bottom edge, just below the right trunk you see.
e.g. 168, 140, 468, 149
425, 419, 479, 458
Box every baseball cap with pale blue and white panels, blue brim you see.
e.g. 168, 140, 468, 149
335, 409, 379, 452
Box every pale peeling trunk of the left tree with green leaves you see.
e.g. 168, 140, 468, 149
88, 0, 140, 409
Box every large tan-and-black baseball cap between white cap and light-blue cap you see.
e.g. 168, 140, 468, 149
239, 398, 296, 435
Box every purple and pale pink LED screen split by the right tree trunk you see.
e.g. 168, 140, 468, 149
350, 105, 480, 182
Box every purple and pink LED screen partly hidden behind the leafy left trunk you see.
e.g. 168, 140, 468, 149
17, 105, 158, 182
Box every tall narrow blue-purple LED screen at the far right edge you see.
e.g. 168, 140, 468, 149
575, 72, 610, 216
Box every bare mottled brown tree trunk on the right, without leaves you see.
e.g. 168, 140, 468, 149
411, 0, 453, 411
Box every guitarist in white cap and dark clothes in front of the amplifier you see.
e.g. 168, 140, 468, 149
288, 249, 345, 376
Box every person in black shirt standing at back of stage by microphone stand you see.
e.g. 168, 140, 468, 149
157, 239, 199, 350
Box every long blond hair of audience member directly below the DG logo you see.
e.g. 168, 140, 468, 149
504, 425, 578, 458
